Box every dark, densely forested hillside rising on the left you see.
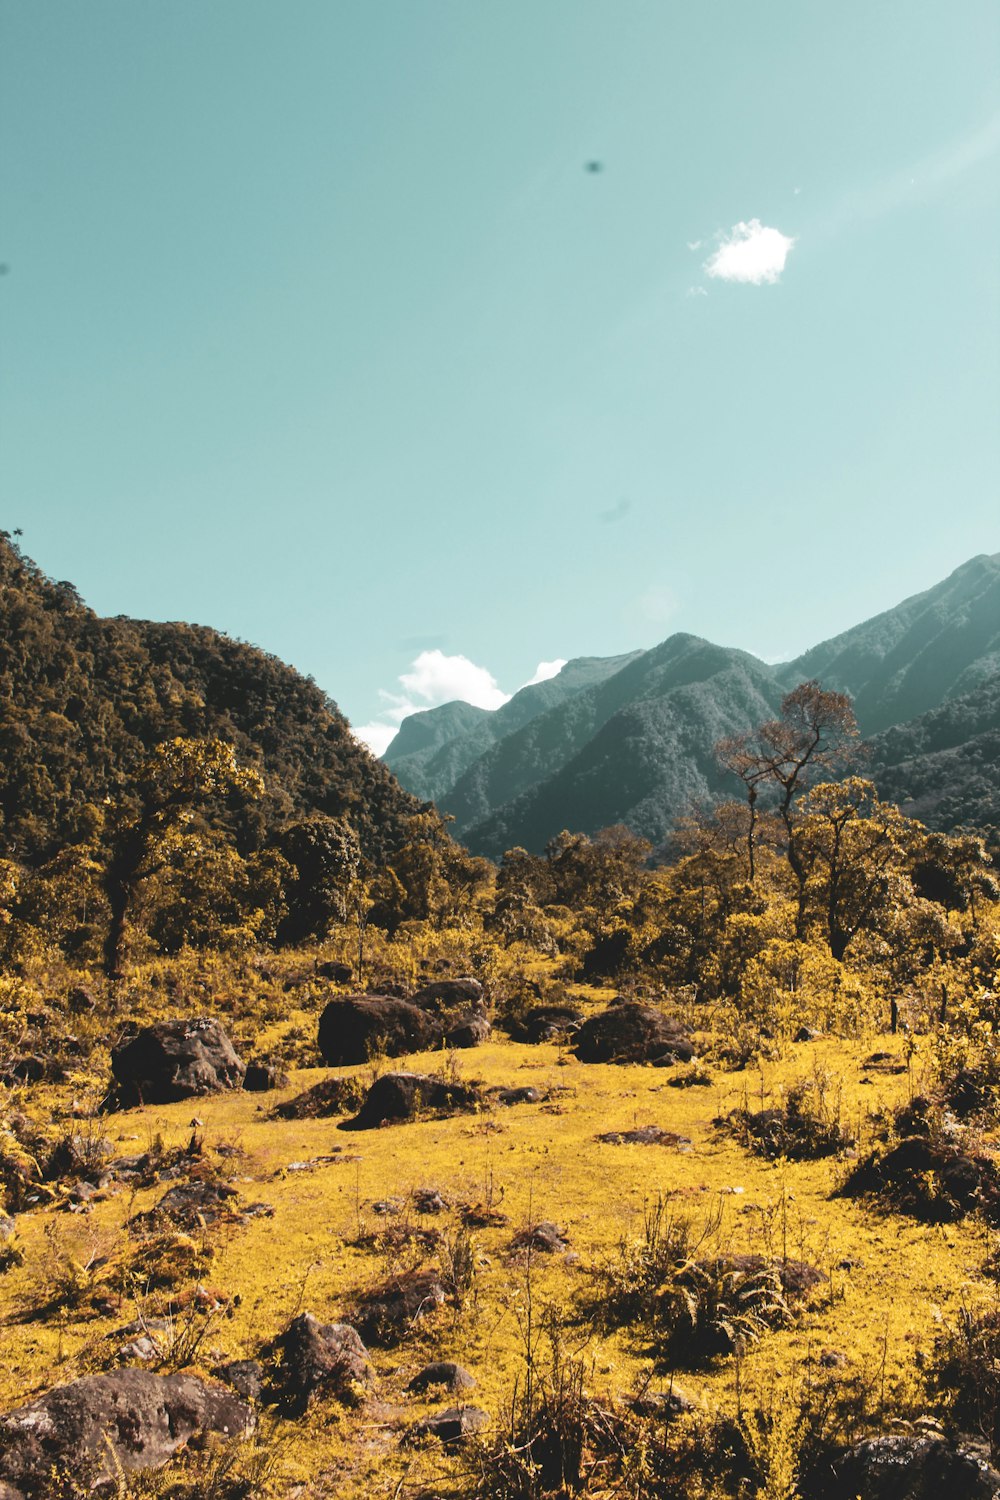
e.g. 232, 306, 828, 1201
0, 533, 418, 863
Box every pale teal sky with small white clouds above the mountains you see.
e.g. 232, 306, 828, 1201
0, 0, 1000, 750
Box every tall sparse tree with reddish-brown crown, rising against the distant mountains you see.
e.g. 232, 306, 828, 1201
715, 680, 858, 938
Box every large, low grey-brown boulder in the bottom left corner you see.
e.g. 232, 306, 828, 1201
0, 1370, 253, 1500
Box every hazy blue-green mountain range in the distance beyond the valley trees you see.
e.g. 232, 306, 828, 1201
387, 555, 1000, 855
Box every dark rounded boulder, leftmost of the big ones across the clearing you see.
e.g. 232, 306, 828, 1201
105, 1017, 246, 1109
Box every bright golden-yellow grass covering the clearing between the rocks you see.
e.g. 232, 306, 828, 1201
0, 966, 996, 1500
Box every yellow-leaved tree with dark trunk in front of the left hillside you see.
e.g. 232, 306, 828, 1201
100, 738, 264, 980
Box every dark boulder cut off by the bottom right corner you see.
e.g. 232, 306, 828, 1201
832, 1433, 1000, 1500
